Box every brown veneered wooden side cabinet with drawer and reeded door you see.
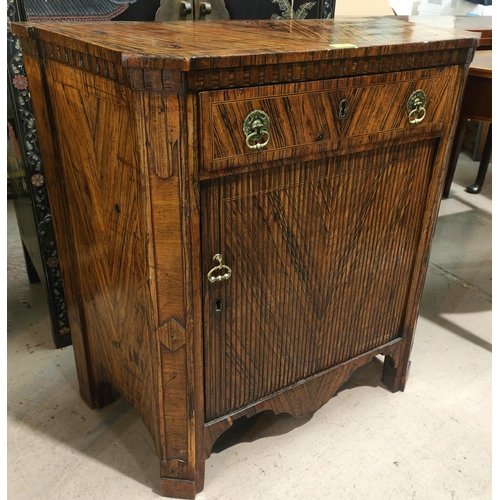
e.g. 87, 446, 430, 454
12, 18, 477, 498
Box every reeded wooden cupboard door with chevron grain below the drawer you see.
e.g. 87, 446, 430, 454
201, 140, 436, 422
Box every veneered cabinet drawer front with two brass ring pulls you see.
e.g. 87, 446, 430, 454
200, 68, 453, 172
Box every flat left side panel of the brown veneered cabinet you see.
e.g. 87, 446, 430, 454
46, 62, 156, 435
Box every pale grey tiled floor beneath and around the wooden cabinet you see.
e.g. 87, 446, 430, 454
7, 154, 494, 500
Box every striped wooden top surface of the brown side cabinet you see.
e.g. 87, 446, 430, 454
12, 17, 480, 71
